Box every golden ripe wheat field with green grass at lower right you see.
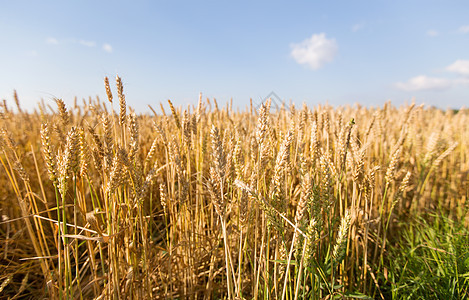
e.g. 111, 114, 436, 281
0, 77, 469, 299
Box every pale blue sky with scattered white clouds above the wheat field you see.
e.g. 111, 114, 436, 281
0, 0, 469, 111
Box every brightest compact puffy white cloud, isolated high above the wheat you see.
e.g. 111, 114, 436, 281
290, 33, 338, 70
